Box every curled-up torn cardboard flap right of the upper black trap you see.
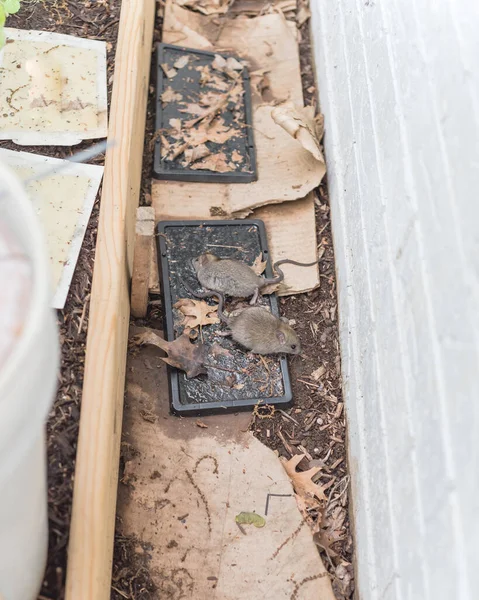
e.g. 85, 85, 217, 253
271, 102, 324, 162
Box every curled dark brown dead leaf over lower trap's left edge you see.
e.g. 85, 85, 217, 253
133, 329, 206, 379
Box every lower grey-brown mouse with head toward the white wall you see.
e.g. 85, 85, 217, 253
182, 281, 301, 354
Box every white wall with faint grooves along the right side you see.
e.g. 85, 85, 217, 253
311, 0, 479, 600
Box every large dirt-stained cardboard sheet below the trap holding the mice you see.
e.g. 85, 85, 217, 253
118, 332, 334, 600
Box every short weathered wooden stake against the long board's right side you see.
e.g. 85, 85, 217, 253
131, 206, 155, 319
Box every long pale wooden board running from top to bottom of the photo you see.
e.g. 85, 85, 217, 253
66, 0, 155, 600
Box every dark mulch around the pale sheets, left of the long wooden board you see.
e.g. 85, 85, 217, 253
0, 0, 159, 600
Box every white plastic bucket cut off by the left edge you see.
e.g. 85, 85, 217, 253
0, 163, 59, 600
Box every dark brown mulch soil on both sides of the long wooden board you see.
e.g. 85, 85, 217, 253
0, 0, 354, 600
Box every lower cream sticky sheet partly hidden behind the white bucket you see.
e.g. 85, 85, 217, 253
0, 149, 103, 309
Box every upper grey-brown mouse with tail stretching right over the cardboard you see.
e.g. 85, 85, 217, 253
192, 252, 317, 304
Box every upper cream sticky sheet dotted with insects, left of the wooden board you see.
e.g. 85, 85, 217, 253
0, 28, 107, 146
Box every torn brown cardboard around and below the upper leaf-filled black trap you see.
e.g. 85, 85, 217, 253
152, 1, 326, 295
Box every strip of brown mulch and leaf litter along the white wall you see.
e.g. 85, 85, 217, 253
246, 10, 354, 600
